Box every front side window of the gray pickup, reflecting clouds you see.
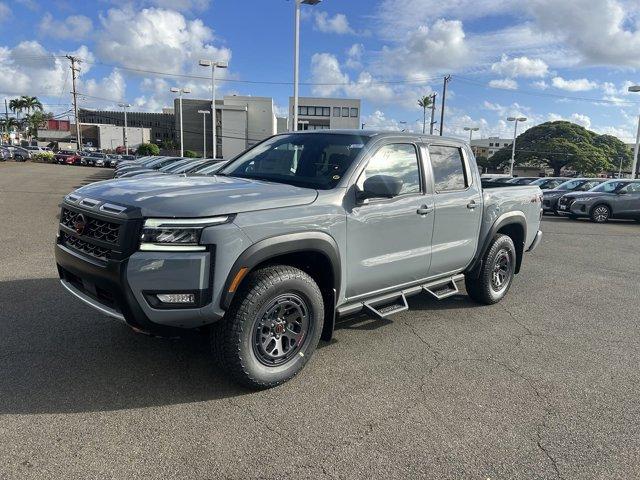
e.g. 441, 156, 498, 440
357, 143, 421, 195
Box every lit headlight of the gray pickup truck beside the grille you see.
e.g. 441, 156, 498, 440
140, 215, 231, 251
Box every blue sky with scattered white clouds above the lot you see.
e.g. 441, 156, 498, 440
0, 0, 640, 143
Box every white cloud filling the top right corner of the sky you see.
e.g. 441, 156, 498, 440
527, 0, 640, 67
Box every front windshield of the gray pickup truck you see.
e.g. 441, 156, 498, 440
220, 133, 369, 190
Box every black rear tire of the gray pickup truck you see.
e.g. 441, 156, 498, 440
465, 234, 516, 305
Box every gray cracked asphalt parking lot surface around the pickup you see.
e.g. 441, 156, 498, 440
0, 163, 640, 480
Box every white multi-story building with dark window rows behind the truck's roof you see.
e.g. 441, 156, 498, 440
289, 97, 360, 130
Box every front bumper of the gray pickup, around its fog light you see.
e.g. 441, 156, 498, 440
55, 243, 222, 336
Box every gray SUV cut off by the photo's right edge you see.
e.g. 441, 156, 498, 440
558, 180, 640, 223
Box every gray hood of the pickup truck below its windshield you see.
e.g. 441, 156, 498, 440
74, 175, 318, 218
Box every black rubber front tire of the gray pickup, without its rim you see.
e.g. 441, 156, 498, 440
211, 265, 324, 389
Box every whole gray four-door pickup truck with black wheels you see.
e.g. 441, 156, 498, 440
55, 130, 542, 388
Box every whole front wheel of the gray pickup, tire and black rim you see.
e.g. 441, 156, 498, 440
211, 265, 324, 388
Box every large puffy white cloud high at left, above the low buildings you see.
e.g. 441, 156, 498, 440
96, 7, 231, 73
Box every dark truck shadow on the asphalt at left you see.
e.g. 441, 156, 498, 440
0, 278, 249, 415
